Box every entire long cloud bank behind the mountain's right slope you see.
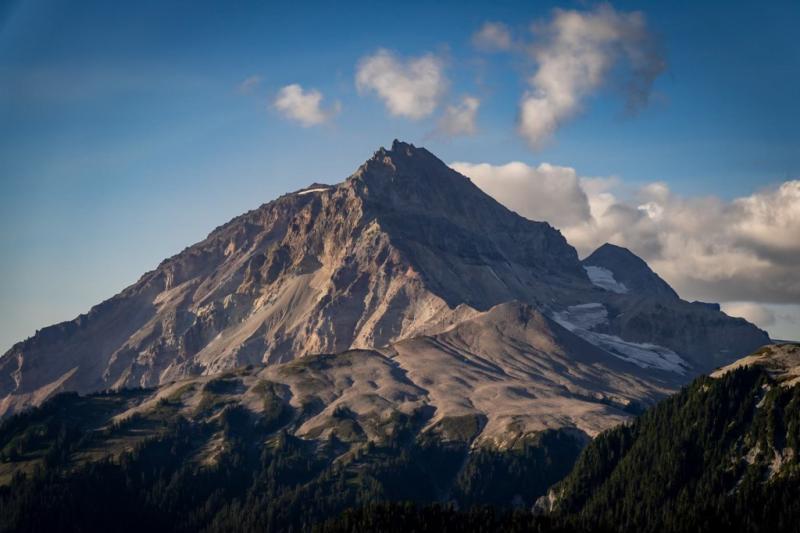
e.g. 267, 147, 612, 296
451, 163, 800, 316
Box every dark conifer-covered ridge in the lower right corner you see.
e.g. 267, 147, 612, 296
538, 344, 800, 532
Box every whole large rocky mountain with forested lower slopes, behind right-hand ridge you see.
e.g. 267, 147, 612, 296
0, 141, 780, 531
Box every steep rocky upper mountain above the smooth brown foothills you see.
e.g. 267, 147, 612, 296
0, 141, 768, 422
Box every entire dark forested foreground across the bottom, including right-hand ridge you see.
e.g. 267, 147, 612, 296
0, 345, 800, 533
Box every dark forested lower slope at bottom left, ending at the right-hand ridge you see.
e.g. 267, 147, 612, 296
0, 380, 583, 532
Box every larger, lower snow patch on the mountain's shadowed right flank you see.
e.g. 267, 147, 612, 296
553, 303, 689, 375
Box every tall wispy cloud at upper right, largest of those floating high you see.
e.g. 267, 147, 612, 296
519, 5, 666, 149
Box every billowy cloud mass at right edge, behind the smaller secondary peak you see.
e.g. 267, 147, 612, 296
562, 180, 800, 303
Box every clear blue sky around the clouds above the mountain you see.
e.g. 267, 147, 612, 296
0, 0, 800, 350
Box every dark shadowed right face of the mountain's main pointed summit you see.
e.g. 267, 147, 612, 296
346, 141, 585, 310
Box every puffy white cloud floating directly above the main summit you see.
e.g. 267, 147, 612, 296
356, 49, 448, 120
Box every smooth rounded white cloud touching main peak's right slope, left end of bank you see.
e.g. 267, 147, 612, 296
450, 161, 591, 227
